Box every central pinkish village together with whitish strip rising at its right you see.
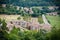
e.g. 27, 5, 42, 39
6, 15, 51, 31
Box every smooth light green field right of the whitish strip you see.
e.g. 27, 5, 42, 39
46, 15, 60, 27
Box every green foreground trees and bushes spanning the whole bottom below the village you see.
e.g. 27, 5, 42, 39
0, 19, 60, 40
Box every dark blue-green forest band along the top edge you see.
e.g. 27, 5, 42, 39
0, 0, 60, 7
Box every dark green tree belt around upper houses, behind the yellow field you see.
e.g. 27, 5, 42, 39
0, 4, 56, 17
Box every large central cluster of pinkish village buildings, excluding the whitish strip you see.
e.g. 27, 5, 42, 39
7, 20, 50, 31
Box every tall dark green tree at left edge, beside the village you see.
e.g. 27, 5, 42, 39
0, 20, 9, 40
